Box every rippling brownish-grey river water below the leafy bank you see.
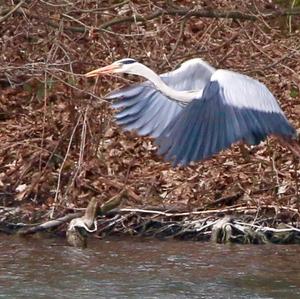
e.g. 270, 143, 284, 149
0, 235, 300, 299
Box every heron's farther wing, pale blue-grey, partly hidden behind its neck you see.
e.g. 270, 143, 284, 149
106, 59, 215, 137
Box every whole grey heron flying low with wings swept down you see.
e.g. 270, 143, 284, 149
85, 58, 300, 165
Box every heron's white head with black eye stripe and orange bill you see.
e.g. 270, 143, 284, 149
85, 58, 142, 77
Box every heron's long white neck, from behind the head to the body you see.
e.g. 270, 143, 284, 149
135, 64, 202, 102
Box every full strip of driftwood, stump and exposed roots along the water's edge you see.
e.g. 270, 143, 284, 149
0, 192, 300, 248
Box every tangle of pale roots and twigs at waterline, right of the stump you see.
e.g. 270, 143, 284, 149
97, 206, 300, 244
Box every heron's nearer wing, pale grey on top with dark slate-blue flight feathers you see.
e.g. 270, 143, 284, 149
156, 70, 296, 165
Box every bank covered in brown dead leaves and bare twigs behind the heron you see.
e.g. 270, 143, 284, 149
0, 0, 300, 244
